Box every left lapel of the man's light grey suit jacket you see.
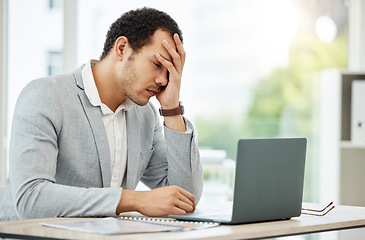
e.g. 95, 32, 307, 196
74, 66, 111, 187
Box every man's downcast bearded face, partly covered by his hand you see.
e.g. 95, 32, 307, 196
119, 30, 176, 106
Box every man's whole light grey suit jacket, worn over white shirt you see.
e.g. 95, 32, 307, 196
0, 64, 202, 220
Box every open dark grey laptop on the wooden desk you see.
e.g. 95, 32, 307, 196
169, 138, 307, 224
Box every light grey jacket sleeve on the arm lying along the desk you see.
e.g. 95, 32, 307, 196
9, 80, 122, 219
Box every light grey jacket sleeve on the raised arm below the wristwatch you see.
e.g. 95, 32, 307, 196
142, 105, 203, 202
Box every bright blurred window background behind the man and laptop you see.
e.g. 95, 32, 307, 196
0, 0, 365, 205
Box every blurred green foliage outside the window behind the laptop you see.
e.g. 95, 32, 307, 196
196, 31, 348, 201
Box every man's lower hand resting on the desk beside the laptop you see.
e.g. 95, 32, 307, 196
116, 186, 195, 217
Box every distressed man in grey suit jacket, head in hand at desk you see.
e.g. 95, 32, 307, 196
0, 8, 202, 220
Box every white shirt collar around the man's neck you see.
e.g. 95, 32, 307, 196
81, 60, 136, 112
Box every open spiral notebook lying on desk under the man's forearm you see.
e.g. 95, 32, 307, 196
40, 217, 219, 235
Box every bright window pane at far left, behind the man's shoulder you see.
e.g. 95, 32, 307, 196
7, 0, 63, 178
